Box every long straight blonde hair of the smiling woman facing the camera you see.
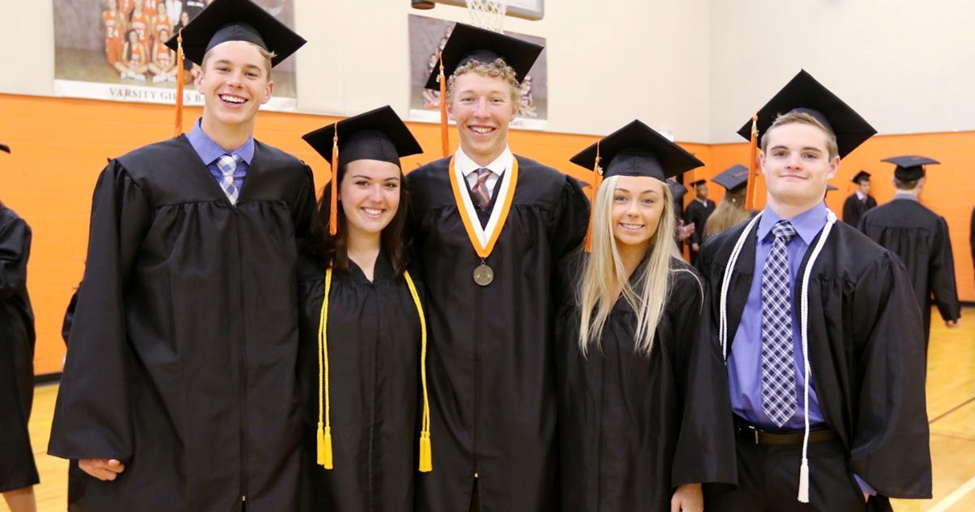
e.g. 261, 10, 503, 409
576, 176, 687, 356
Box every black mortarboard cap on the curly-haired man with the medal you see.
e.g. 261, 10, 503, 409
425, 23, 544, 90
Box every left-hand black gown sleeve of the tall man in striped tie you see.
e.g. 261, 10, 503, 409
48, 161, 150, 463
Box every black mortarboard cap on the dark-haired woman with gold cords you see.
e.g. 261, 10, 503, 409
301, 105, 423, 170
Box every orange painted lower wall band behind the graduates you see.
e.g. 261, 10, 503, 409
0, 94, 975, 374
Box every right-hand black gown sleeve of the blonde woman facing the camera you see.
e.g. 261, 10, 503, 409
668, 272, 738, 488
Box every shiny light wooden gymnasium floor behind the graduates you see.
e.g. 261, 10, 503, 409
7, 307, 975, 512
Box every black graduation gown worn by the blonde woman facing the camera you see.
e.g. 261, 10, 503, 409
555, 255, 737, 512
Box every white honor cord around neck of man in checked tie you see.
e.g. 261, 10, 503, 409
718, 210, 836, 503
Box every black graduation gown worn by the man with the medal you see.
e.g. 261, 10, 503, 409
407, 156, 589, 512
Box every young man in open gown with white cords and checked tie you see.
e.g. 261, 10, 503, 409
699, 71, 931, 511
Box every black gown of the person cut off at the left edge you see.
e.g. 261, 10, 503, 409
0, 204, 40, 492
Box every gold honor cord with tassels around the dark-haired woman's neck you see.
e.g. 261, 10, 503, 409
317, 267, 433, 473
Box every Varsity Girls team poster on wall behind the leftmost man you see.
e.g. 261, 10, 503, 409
52, 0, 297, 111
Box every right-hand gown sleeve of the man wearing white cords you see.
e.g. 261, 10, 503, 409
850, 253, 931, 498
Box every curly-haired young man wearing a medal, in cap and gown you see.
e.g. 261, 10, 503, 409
407, 24, 589, 512
